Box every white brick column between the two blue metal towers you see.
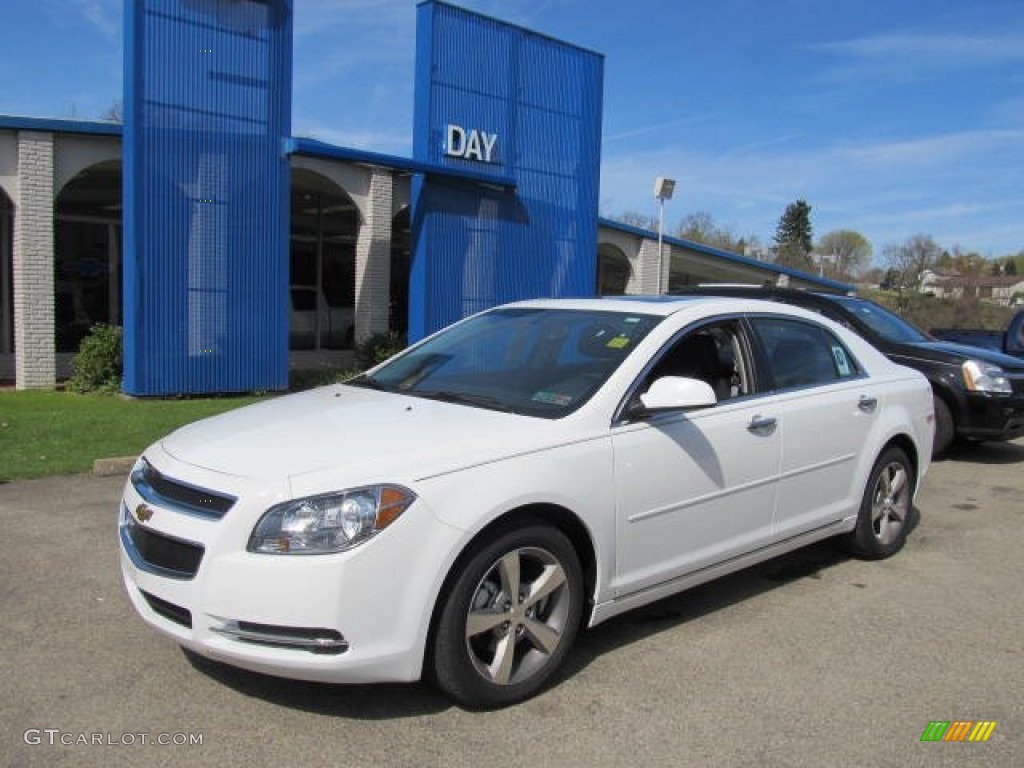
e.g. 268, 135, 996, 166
355, 168, 393, 343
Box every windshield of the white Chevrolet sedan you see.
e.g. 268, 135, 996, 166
349, 307, 662, 419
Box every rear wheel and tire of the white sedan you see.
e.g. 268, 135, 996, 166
848, 445, 914, 560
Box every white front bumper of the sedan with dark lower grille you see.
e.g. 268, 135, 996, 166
119, 455, 461, 683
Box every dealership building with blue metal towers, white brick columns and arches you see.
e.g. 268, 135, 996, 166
0, 0, 848, 395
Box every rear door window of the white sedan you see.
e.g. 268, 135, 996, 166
752, 317, 860, 389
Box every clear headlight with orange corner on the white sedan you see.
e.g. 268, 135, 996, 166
249, 485, 416, 555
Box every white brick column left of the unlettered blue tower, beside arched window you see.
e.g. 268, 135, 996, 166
13, 131, 56, 389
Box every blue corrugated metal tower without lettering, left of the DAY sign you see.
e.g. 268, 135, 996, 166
124, 0, 292, 395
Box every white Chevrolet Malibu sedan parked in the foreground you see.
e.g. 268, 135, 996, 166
120, 297, 934, 708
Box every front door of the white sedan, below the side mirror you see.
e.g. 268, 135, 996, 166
612, 321, 780, 596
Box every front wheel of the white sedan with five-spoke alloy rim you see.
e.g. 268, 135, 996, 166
432, 524, 584, 709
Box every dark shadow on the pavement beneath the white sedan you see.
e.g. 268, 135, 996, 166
176, 508, 921, 720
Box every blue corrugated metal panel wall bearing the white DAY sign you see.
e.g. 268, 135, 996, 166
410, 0, 604, 340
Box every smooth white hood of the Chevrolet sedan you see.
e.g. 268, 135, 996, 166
162, 385, 558, 482
